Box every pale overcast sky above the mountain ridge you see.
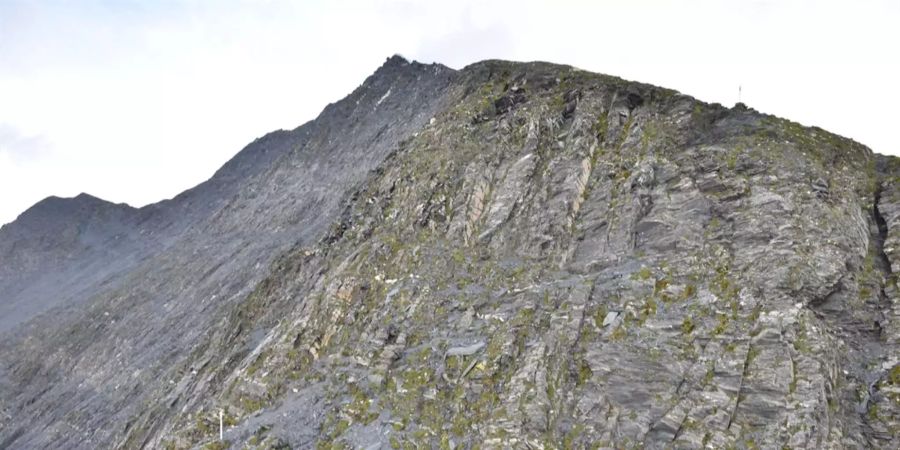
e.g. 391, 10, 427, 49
0, 0, 900, 224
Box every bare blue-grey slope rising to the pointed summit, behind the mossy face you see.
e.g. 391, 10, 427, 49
0, 57, 453, 448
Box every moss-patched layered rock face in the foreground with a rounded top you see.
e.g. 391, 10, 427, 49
139, 62, 897, 448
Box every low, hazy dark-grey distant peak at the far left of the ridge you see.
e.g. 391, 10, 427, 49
0, 194, 140, 331
